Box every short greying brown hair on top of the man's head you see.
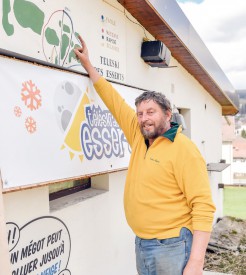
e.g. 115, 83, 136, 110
135, 91, 172, 113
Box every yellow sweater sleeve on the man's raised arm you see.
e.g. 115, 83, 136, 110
94, 77, 139, 147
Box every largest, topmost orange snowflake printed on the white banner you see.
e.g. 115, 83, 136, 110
21, 80, 42, 111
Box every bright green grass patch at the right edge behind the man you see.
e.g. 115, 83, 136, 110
223, 186, 246, 219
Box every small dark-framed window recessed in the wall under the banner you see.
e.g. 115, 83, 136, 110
49, 178, 91, 201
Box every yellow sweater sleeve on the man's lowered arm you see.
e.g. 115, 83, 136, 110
179, 145, 215, 232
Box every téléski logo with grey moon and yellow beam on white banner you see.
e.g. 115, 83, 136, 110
54, 82, 130, 162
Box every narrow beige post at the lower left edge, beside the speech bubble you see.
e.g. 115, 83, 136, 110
0, 171, 11, 275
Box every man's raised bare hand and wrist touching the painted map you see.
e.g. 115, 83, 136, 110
74, 35, 100, 83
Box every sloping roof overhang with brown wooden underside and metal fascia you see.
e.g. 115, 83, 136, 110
117, 0, 238, 115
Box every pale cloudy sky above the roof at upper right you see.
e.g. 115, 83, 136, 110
177, 0, 246, 90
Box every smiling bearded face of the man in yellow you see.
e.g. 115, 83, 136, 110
137, 100, 171, 142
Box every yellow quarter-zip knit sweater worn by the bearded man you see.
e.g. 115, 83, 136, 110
94, 77, 215, 239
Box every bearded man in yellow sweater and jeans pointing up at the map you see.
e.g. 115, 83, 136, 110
74, 37, 215, 275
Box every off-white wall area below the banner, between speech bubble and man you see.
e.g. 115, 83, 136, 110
4, 171, 136, 275
